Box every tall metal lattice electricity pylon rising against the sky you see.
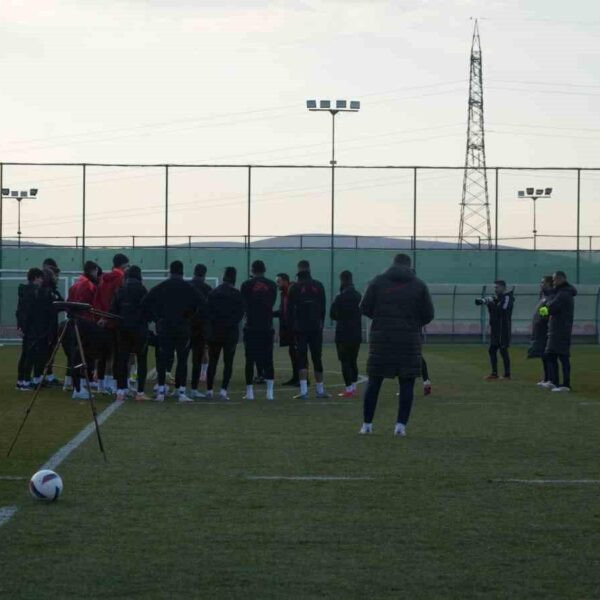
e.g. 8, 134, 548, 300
458, 20, 492, 248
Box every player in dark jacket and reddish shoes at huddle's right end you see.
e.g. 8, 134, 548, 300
329, 271, 362, 398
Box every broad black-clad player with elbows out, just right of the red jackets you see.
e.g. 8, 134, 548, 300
142, 260, 206, 402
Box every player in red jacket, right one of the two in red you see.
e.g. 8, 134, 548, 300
93, 253, 129, 393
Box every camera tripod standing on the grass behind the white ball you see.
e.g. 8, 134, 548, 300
6, 302, 120, 462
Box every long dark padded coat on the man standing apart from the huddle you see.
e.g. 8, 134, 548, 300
360, 266, 434, 378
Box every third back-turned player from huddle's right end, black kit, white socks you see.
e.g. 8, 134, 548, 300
241, 260, 277, 400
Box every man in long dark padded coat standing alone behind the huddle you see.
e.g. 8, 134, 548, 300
360, 254, 434, 436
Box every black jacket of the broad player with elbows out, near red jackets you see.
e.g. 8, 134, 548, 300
142, 276, 203, 336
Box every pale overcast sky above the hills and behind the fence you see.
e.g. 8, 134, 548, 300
0, 0, 600, 247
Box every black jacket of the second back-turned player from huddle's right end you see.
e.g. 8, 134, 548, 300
288, 274, 327, 333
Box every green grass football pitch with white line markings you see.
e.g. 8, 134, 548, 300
0, 345, 600, 599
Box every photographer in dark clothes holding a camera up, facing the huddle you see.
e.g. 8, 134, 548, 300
475, 279, 515, 381
